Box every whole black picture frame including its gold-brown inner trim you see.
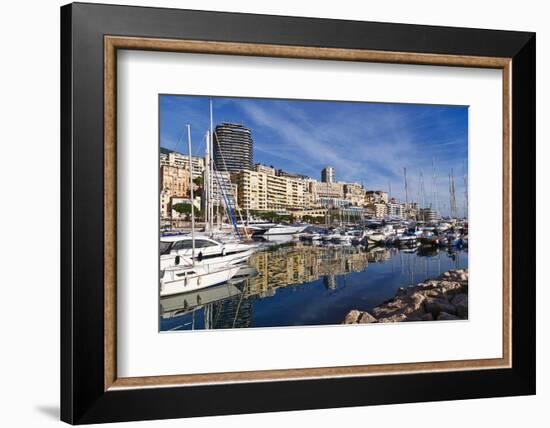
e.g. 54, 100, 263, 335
61, 3, 536, 424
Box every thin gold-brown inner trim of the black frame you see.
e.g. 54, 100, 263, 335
104, 36, 512, 391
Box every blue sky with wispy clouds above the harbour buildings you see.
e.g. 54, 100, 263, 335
160, 95, 468, 215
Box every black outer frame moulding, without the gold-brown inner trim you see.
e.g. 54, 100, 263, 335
61, 3, 536, 424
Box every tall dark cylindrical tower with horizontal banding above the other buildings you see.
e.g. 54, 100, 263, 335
213, 122, 254, 173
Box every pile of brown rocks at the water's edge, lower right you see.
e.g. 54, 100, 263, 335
343, 269, 468, 324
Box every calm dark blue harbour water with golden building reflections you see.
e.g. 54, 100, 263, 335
160, 240, 468, 331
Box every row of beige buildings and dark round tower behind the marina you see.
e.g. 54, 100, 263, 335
159, 123, 438, 224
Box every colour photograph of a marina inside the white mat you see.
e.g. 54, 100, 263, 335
159, 94, 468, 331
